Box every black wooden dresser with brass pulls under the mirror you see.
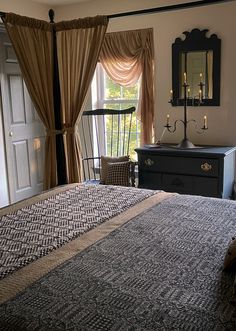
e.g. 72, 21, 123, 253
135, 146, 236, 199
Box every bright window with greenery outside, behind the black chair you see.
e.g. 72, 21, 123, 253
92, 63, 141, 160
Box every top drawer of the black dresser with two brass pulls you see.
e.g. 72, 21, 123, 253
139, 155, 219, 177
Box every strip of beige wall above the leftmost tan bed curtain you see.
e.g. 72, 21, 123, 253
0, 0, 49, 20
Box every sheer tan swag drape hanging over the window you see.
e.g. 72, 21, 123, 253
99, 29, 154, 144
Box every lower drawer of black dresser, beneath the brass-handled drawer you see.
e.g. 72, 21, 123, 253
162, 174, 220, 197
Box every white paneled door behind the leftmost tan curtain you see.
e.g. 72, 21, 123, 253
0, 31, 45, 203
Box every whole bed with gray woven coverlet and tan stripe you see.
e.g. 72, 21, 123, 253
0, 184, 236, 331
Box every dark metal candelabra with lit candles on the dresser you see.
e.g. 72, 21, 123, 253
164, 73, 208, 149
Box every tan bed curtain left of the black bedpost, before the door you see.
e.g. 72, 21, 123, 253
4, 13, 57, 189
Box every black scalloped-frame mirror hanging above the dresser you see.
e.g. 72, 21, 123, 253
171, 29, 221, 106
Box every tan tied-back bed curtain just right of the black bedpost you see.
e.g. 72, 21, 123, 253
55, 16, 108, 183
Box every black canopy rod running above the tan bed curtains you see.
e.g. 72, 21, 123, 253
0, 0, 235, 21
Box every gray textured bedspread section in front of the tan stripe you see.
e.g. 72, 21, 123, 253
0, 195, 236, 331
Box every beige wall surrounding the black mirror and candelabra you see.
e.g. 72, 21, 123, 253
55, 0, 236, 145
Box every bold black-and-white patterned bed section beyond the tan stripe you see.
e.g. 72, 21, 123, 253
0, 185, 157, 279
